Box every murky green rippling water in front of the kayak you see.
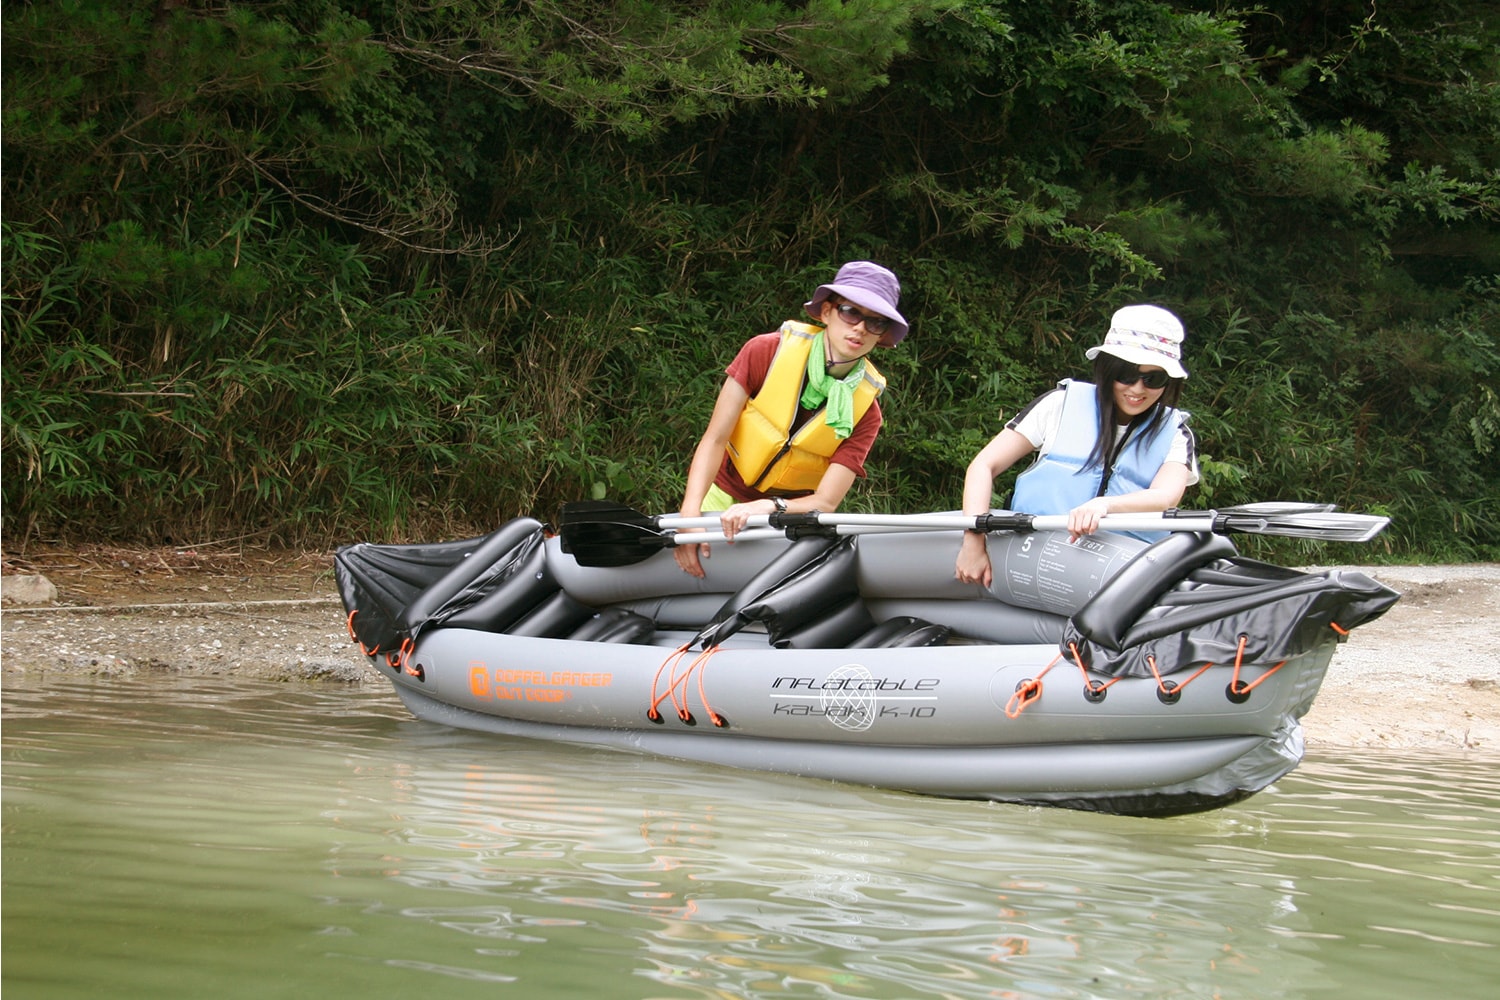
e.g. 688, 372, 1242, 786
0, 679, 1500, 1000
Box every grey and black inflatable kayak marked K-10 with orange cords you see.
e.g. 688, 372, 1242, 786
335, 503, 1398, 816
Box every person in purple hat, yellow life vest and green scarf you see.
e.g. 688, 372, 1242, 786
672, 261, 908, 577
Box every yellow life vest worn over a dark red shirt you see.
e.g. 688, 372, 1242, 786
729, 319, 885, 493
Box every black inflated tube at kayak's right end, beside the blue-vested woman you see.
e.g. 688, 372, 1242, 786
1073, 532, 1235, 652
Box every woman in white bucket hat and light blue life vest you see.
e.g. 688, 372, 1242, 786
954, 306, 1199, 586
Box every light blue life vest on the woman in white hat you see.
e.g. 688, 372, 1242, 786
1011, 379, 1188, 541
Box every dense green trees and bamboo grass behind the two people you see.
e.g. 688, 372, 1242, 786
0, 0, 1500, 561
